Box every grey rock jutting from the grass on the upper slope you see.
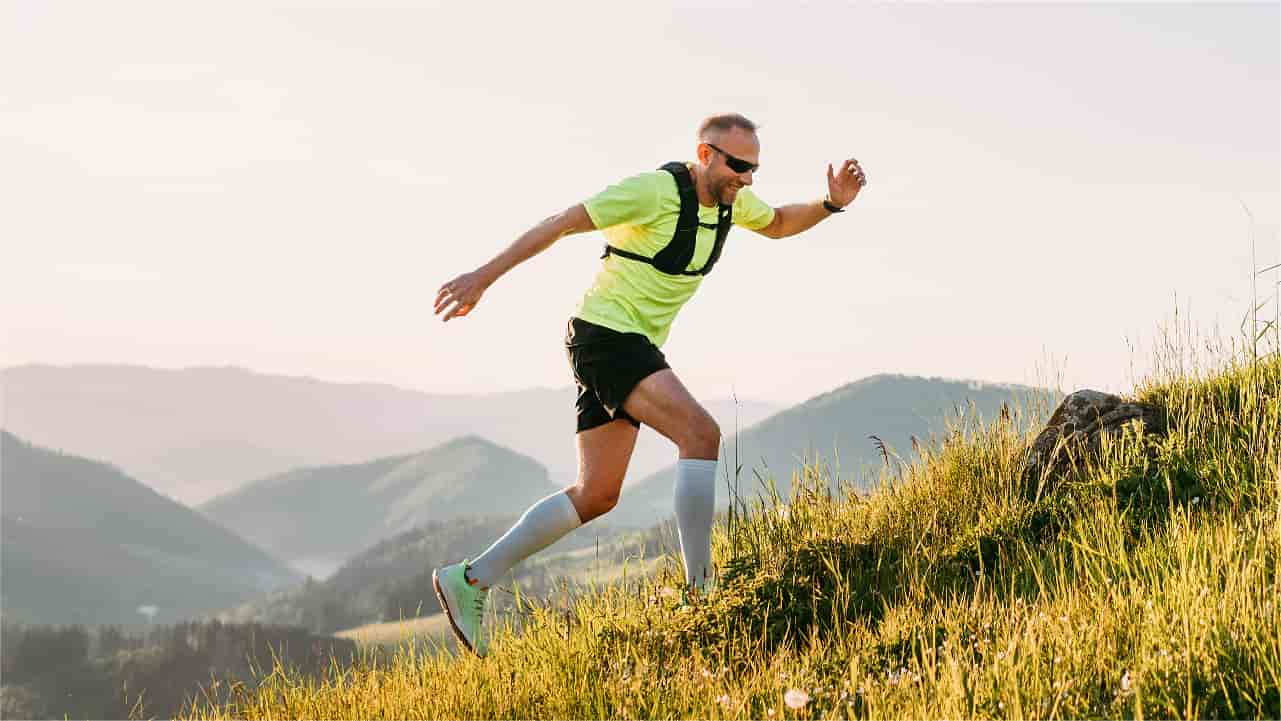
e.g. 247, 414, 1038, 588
1022, 389, 1164, 497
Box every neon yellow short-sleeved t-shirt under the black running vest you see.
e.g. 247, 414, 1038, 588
574, 170, 774, 347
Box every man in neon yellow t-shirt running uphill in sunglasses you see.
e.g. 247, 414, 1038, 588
432, 114, 867, 656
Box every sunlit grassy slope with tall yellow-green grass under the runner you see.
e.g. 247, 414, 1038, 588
183, 340, 1281, 718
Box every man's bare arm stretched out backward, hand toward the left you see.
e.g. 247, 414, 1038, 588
436, 204, 596, 320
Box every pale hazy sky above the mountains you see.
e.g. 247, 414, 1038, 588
0, 1, 1281, 402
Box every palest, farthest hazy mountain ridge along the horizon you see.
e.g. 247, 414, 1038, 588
0, 365, 780, 505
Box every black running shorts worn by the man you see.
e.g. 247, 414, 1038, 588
565, 318, 671, 432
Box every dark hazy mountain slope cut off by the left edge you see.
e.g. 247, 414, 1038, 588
0, 432, 304, 626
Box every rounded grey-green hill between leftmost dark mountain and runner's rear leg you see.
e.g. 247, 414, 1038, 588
199, 435, 557, 576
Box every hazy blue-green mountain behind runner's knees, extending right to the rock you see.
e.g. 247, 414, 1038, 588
603, 374, 1058, 526
